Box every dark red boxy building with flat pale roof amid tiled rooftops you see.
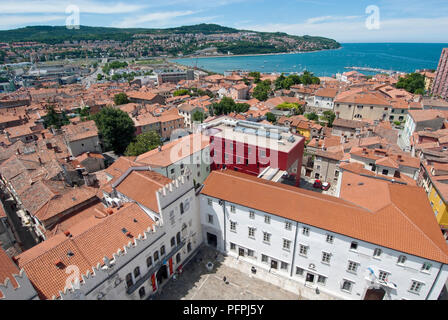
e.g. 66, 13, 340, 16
202, 117, 305, 186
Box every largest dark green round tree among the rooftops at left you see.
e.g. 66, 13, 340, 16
93, 107, 136, 155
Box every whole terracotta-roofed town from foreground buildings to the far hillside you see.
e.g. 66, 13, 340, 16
0, 25, 448, 300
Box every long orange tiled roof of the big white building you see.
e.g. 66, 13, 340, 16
201, 171, 448, 263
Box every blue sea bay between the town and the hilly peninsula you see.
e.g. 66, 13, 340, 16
172, 43, 448, 77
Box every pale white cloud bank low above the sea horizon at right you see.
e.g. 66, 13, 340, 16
245, 17, 448, 43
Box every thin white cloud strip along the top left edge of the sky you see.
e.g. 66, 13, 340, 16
0, 0, 146, 14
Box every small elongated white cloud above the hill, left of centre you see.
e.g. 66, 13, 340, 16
116, 10, 196, 28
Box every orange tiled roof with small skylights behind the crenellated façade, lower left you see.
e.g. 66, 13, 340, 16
16, 203, 154, 299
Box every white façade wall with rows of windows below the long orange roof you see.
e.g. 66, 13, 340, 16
200, 195, 448, 300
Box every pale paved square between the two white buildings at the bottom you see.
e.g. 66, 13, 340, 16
154, 246, 299, 300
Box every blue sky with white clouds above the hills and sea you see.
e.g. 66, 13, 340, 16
0, 0, 448, 43
